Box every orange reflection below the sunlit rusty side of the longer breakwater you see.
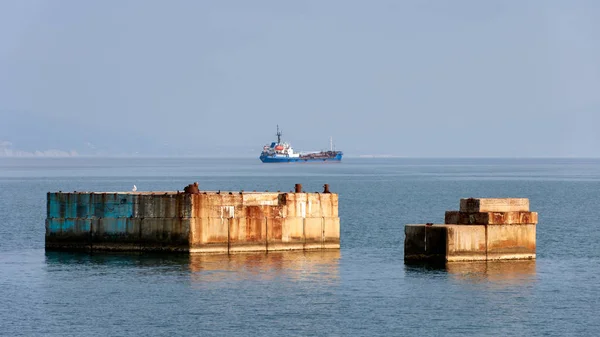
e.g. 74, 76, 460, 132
190, 250, 340, 283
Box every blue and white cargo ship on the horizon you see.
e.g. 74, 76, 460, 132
260, 125, 343, 163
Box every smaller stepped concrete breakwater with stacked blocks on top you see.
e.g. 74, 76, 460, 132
404, 198, 538, 262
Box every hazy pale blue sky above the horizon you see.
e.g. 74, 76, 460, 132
0, 0, 600, 157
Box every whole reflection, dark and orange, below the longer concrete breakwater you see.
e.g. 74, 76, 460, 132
45, 250, 340, 283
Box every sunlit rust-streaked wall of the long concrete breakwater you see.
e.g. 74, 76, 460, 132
190, 192, 340, 253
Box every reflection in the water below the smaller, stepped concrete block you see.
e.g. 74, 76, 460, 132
405, 260, 536, 285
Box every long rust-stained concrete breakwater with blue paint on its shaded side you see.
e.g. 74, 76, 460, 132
45, 184, 340, 253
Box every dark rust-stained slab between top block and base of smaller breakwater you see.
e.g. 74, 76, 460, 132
444, 211, 538, 225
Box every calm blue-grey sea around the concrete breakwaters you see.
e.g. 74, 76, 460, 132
0, 158, 600, 337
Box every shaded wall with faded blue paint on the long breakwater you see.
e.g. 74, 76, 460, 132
46, 192, 191, 251
